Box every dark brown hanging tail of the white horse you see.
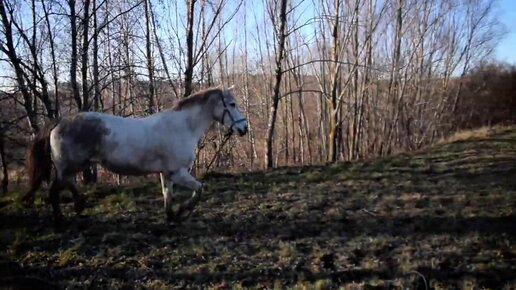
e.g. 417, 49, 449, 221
23, 120, 59, 204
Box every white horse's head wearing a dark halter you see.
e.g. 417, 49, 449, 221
213, 86, 247, 136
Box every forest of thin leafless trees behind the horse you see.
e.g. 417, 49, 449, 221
0, 0, 516, 192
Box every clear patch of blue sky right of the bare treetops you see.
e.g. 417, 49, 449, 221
495, 0, 516, 64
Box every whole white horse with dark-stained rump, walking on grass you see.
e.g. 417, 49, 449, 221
22, 86, 247, 222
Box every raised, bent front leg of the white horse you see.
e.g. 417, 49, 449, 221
171, 168, 203, 221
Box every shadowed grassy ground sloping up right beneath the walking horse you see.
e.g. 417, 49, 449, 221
0, 128, 516, 289
